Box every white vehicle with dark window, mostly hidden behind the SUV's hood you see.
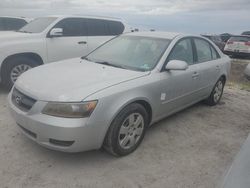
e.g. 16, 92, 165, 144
0, 16, 32, 31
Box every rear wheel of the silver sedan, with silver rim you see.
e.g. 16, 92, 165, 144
205, 77, 225, 106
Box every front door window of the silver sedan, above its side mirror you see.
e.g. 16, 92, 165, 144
168, 39, 194, 65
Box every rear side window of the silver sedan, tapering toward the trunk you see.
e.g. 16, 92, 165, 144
194, 39, 219, 63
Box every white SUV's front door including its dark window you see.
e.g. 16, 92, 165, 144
46, 18, 88, 62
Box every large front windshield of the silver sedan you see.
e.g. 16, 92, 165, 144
85, 36, 170, 71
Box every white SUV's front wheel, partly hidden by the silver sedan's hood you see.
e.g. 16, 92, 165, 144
2, 57, 38, 89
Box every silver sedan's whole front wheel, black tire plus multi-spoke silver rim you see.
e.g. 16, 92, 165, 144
104, 103, 149, 156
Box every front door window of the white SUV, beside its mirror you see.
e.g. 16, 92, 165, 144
54, 18, 88, 37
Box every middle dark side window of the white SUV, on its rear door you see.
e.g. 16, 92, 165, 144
87, 19, 109, 36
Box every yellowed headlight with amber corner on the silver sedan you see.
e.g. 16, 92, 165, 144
42, 101, 97, 118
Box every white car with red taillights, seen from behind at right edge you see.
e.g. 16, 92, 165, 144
224, 35, 250, 57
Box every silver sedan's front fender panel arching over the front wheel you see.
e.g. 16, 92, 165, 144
85, 76, 161, 148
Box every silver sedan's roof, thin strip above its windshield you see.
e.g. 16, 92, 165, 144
125, 31, 183, 39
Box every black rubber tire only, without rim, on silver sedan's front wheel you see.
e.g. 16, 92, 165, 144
103, 103, 149, 156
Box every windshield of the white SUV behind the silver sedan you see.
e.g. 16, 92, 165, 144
18, 17, 57, 33
